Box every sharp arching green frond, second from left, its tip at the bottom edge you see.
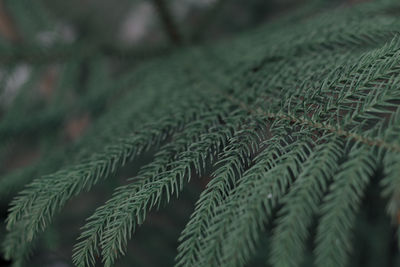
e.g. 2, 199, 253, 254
74, 105, 241, 266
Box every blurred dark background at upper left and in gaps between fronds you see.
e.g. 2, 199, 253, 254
0, 0, 399, 267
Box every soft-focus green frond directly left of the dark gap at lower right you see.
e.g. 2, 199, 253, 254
315, 147, 377, 266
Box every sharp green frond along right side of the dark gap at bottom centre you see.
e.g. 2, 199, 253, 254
177, 122, 267, 266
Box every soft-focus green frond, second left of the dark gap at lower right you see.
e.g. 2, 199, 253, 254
270, 137, 344, 267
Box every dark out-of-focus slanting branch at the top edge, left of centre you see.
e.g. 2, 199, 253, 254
153, 0, 182, 44
